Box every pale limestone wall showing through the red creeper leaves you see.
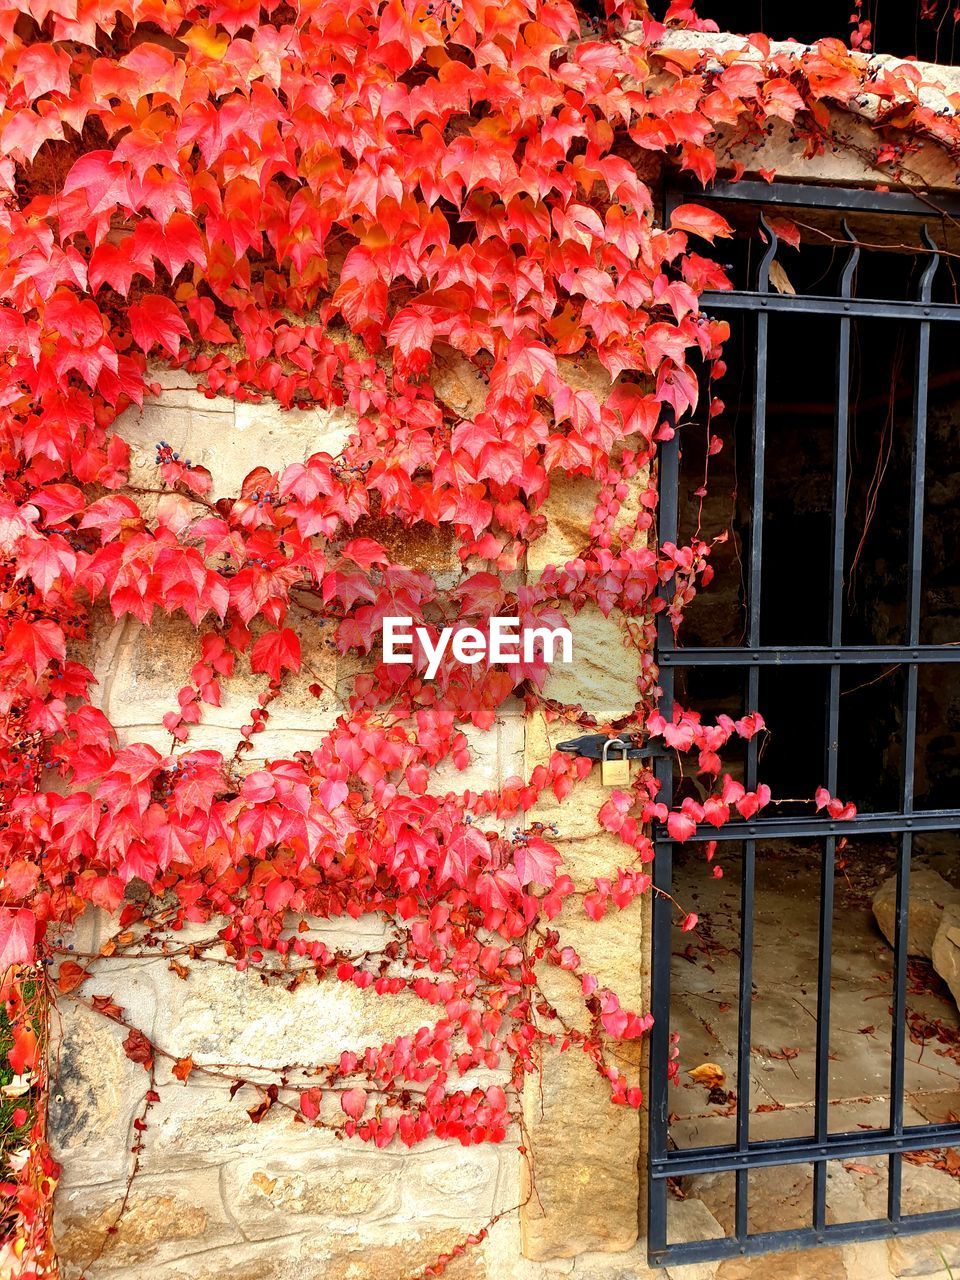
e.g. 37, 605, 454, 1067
51, 369, 660, 1280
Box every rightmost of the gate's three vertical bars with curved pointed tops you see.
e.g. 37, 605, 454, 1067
887, 227, 940, 1224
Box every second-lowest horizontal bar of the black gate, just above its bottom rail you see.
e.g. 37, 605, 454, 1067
650, 1124, 960, 1182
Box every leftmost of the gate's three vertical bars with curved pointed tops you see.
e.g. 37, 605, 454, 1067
736, 280, 777, 1243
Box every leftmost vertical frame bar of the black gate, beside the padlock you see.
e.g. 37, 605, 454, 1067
646, 407, 680, 1257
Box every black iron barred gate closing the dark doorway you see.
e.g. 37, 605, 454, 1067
648, 182, 960, 1265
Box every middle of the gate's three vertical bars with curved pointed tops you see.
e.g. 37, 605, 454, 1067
813, 223, 860, 1233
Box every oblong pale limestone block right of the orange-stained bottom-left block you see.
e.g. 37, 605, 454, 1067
223, 1143, 401, 1240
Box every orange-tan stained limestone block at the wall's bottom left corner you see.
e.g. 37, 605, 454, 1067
54, 1175, 242, 1280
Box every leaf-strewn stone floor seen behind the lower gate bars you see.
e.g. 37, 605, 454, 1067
669, 841, 960, 1276
